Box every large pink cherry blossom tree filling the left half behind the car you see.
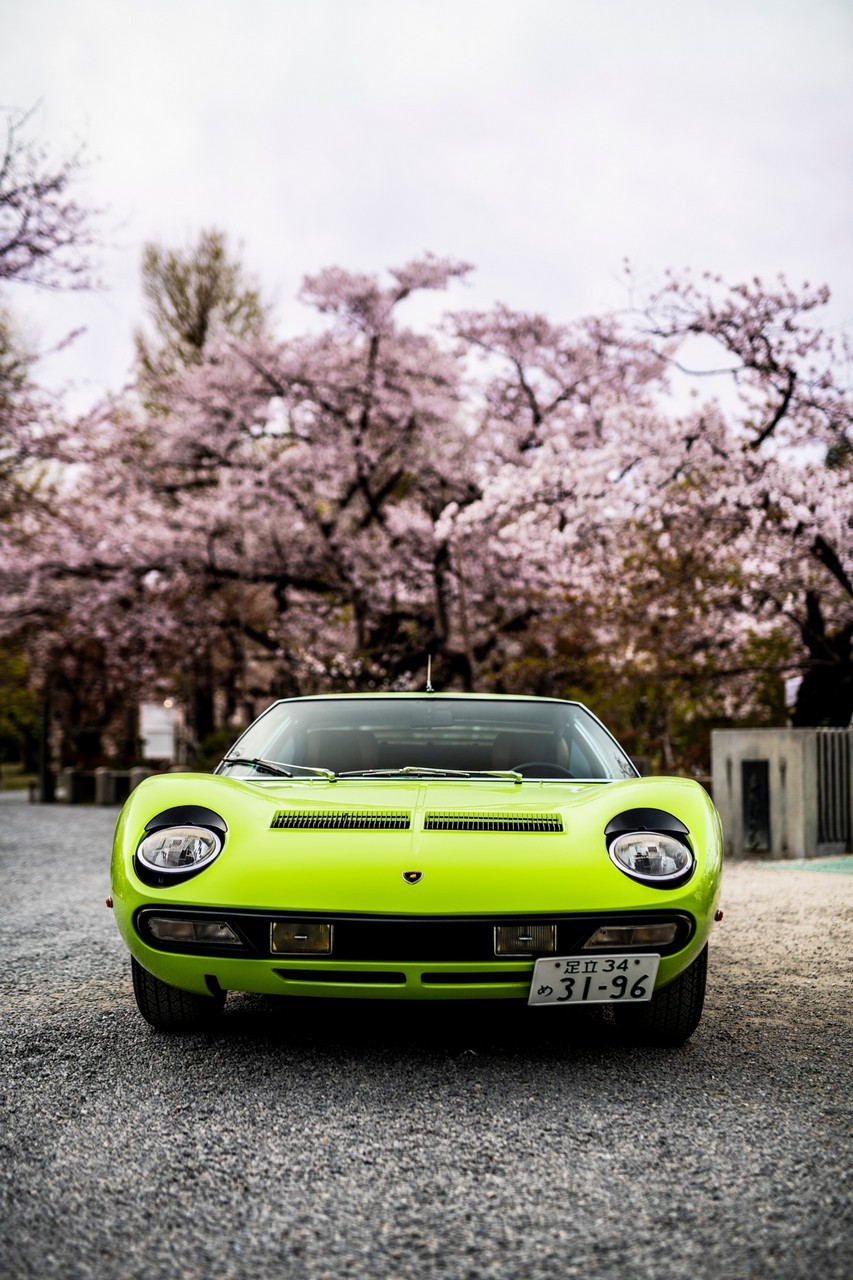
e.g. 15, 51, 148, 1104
0, 259, 467, 762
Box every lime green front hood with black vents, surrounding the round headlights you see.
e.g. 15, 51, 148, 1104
113, 774, 721, 915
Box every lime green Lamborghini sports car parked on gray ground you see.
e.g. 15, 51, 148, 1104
111, 692, 722, 1044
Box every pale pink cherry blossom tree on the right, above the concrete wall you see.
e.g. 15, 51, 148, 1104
435, 273, 853, 755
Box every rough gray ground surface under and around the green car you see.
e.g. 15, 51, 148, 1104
0, 795, 853, 1280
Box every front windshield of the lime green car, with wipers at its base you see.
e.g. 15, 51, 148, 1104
216, 694, 637, 782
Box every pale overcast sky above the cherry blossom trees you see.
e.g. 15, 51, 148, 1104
0, 0, 853, 402
